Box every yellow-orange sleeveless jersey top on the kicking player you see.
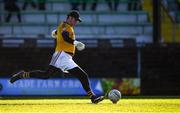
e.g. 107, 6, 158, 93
55, 22, 75, 54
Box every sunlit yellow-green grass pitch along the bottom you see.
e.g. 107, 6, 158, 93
0, 98, 180, 113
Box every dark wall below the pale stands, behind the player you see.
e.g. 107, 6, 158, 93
0, 40, 180, 95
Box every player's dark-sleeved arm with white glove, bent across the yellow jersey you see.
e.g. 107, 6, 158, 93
62, 30, 85, 51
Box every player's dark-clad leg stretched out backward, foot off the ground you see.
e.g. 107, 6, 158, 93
10, 65, 58, 83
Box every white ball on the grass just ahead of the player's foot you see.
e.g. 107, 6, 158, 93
108, 89, 121, 104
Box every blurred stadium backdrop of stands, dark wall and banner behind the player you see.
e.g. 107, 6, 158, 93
0, 0, 180, 96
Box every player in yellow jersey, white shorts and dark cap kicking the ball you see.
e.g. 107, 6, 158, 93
10, 11, 104, 104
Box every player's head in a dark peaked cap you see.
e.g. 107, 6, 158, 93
67, 10, 82, 26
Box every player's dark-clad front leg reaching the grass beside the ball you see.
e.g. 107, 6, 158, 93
68, 67, 104, 104
